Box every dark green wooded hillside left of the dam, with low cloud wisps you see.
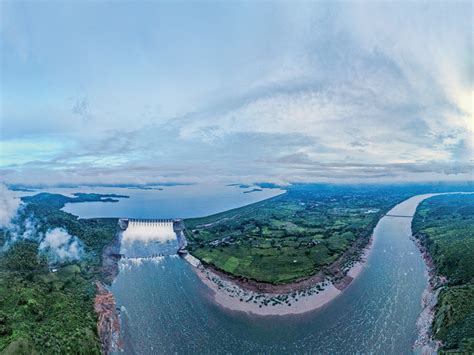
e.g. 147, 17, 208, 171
0, 194, 117, 354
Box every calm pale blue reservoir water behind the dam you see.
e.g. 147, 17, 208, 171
59, 183, 283, 218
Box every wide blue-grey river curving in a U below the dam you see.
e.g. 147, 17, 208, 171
108, 195, 431, 354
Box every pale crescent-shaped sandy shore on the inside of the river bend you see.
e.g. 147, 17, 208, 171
183, 234, 374, 316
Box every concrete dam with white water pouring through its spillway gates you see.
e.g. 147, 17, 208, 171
118, 218, 186, 258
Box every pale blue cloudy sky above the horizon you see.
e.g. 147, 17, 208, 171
0, 0, 474, 184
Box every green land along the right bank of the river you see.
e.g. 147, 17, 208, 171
413, 195, 474, 353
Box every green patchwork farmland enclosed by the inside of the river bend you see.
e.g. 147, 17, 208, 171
185, 185, 410, 284
